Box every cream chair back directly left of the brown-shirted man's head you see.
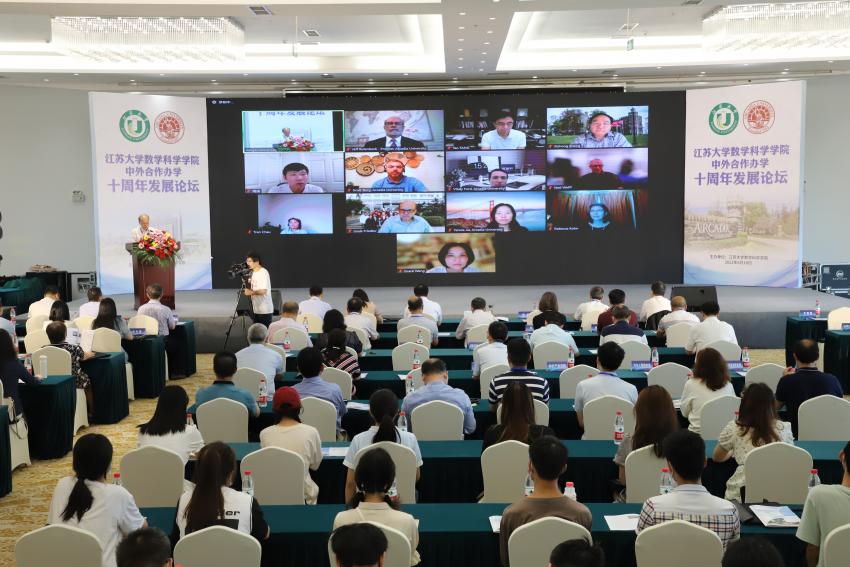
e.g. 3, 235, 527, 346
479, 440, 528, 504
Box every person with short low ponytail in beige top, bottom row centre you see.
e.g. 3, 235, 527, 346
334, 447, 420, 565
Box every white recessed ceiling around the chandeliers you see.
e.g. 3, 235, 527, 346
0, 0, 850, 95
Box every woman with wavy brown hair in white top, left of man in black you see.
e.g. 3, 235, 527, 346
681, 348, 735, 433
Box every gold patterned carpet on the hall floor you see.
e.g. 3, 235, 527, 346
0, 349, 785, 566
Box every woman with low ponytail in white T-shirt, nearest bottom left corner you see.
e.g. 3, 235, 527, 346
47, 433, 147, 567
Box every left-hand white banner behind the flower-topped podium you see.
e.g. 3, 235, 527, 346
89, 93, 212, 294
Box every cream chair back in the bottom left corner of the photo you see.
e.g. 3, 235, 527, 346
15, 524, 102, 567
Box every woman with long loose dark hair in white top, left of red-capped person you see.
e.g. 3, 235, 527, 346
136, 386, 204, 465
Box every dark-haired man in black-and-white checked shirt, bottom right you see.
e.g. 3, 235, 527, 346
636, 429, 741, 549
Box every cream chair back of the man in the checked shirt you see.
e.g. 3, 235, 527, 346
635, 520, 723, 567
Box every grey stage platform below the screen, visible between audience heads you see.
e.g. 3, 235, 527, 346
70, 286, 850, 352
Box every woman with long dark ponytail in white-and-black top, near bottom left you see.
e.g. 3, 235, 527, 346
172, 441, 271, 542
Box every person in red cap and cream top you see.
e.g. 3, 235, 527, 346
260, 386, 322, 504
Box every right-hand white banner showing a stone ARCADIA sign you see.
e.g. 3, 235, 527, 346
684, 82, 805, 287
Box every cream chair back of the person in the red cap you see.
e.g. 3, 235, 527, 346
239, 447, 308, 506
